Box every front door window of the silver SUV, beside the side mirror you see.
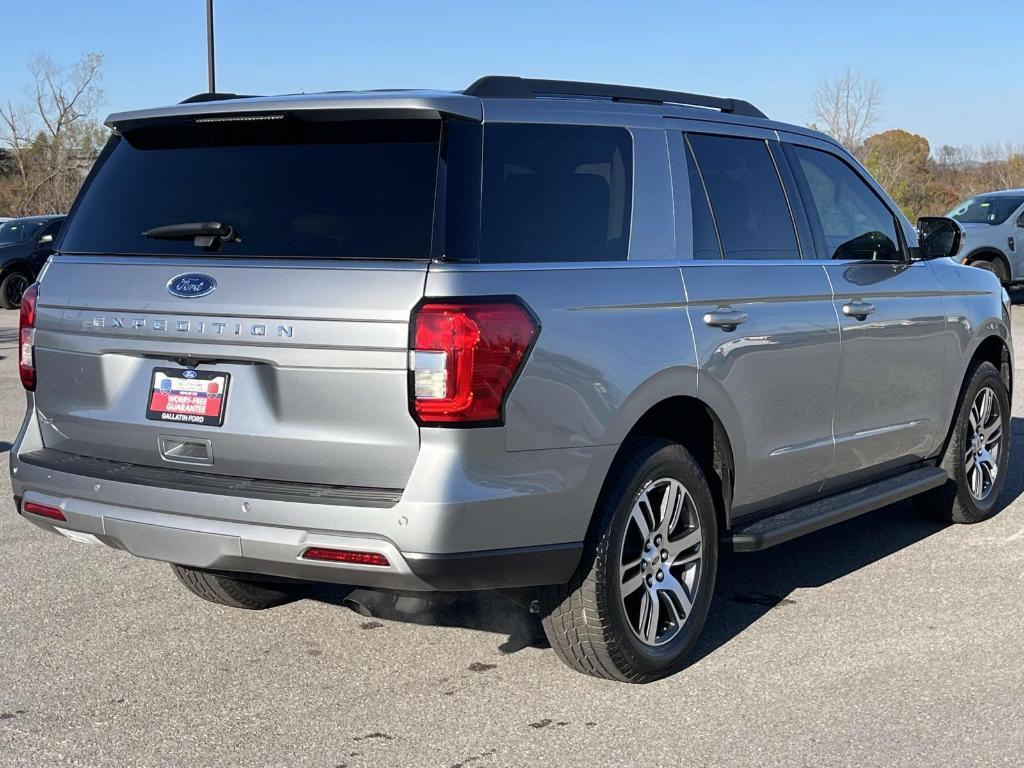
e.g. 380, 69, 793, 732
793, 146, 902, 261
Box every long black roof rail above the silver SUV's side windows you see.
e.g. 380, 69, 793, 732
463, 75, 768, 119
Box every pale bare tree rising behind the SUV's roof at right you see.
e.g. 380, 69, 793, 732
812, 67, 882, 153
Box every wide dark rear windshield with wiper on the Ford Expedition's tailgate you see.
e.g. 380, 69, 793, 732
61, 116, 441, 259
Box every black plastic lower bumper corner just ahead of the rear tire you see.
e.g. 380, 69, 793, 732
402, 542, 583, 592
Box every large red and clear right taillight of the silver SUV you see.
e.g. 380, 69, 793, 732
411, 299, 540, 426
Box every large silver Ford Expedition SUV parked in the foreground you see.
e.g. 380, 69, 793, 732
10, 77, 1013, 682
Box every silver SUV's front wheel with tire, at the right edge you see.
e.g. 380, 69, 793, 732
914, 362, 1010, 523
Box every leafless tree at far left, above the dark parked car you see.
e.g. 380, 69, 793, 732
0, 53, 104, 215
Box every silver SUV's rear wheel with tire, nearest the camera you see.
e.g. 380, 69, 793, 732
539, 438, 718, 683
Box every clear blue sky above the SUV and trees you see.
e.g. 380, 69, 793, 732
0, 0, 1024, 147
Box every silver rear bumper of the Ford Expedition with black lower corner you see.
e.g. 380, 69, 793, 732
10, 412, 614, 591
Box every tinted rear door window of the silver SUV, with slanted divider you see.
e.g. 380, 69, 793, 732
689, 134, 800, 259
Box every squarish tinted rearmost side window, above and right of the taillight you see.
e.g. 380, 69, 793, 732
479, 125, 633, 262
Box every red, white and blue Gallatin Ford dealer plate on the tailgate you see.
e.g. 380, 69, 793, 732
145, 368, 230, 427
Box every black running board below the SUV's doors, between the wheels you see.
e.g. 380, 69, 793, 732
723, 467, 949, 552
